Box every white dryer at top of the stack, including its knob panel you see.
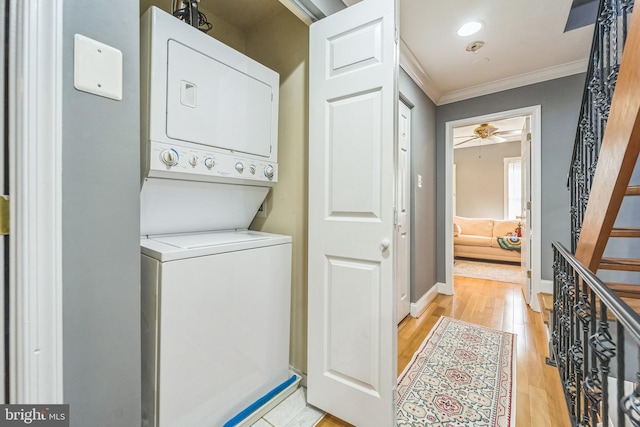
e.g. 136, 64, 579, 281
140, 6, 280, 185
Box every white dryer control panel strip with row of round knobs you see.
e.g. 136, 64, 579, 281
148, 142, 278, 185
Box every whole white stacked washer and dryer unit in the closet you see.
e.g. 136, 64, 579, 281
140, 7, 293, 427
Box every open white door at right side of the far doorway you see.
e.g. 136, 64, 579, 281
519, 116, 533, 304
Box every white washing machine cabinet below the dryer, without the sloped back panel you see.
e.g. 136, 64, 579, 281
141, 231, 291, 427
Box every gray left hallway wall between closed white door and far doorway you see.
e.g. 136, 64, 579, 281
400, 69, 436, 302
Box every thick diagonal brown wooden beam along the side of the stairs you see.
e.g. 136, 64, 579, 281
575, 5, 640, 272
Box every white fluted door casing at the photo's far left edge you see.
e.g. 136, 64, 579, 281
6, 0, 63, 404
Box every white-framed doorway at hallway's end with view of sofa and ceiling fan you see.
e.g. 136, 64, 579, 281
440, 106, 541, 310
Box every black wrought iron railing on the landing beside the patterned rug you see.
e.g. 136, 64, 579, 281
553, 243, 640, 427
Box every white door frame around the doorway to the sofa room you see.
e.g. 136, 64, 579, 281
438, 105, 542, 311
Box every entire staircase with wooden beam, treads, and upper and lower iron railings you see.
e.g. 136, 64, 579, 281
540, 0, 640, 427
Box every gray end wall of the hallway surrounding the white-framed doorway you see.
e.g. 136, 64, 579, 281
436, 74, 585, 282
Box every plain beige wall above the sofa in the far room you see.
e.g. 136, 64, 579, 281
453, 142, 520, 219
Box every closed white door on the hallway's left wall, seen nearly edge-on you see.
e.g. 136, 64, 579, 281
396, 101, 411, 323
